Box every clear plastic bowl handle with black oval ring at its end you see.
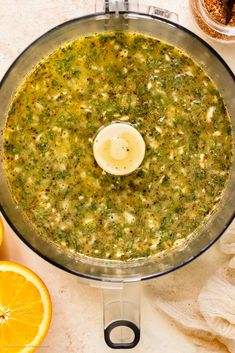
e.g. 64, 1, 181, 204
103, 282, 141, 349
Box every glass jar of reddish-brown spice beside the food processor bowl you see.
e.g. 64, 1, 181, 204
189, 0, 235, 43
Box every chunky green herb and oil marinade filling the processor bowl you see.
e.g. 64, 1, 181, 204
4, 32, 233, 261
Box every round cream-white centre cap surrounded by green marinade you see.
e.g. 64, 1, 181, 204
93, 122, 145, 175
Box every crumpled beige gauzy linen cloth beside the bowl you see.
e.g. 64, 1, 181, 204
145, 221, 235, 353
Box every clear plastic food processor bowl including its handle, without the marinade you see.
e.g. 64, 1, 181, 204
0, 0, 235, 349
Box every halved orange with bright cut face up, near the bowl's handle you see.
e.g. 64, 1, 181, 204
0, 261, 52, 353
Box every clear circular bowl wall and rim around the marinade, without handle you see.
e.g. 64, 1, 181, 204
0, 1, 235, 282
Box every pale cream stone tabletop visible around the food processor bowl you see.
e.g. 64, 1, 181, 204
0, 0, 235, 353
